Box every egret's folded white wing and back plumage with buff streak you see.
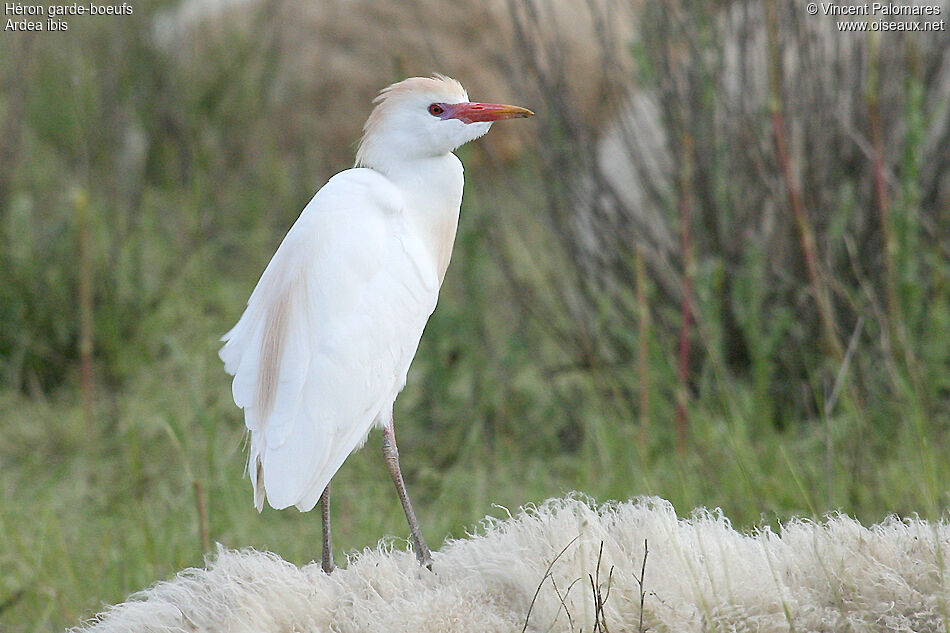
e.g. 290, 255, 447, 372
220, 169, 439, 510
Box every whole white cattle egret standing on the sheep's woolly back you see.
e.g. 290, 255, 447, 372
220, 75, 533, 572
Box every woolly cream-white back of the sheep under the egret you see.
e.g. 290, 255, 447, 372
72, 495, 950, 633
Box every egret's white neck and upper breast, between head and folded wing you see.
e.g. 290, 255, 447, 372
382, 153, 464, 285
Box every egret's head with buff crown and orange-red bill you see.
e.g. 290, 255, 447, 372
356, 75, 534, 169
